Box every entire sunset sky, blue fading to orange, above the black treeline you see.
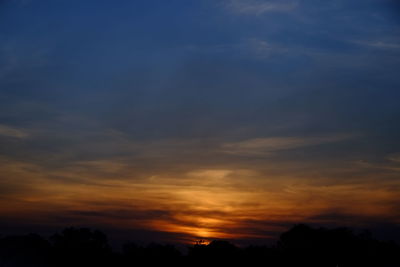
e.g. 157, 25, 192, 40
0, 0, 400, 246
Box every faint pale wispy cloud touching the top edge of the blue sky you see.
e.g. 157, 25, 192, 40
225, 0, 297, 16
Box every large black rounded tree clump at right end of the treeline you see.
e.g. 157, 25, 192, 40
278, 224, 400, 267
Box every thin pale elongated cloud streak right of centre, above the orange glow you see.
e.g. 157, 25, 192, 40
222, 135, 351, 155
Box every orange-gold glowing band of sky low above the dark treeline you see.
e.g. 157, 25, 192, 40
0, 157, 400, 242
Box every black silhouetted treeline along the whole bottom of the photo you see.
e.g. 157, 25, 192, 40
0, 224, 400, 267
